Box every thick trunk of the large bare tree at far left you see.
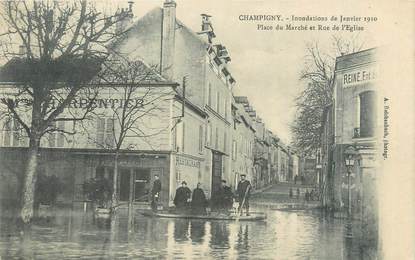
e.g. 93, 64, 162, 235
20, 138, 40, 224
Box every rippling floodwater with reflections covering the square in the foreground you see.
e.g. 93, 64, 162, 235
0, 207, 375, 260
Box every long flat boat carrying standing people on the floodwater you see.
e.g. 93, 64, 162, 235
141, 212, 267, 221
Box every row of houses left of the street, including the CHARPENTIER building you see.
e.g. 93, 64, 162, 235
0, 1, 300, 205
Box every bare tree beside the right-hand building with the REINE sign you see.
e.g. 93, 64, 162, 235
291, 35, 363, 155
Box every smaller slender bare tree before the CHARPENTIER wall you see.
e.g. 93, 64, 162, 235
83, 54, 175, 219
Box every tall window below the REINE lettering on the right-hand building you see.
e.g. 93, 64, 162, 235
359, 91, 376, 137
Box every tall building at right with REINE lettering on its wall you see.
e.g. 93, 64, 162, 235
320, 48, 383, 242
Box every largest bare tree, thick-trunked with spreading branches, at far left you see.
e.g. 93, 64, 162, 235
0, 0, 130, 224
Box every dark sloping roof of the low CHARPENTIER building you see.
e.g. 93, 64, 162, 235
0, 53, 178, 87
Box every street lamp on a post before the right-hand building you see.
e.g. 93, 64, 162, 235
343, 146, 357, 238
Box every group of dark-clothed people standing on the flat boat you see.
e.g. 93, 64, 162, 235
151, 174, 251, 215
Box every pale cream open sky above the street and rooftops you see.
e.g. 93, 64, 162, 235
4, 0, 382, 144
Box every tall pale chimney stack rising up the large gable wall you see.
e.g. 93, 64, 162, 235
160, 0, 176, 80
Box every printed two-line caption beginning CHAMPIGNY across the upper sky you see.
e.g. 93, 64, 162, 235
238, 14, 379, 32
